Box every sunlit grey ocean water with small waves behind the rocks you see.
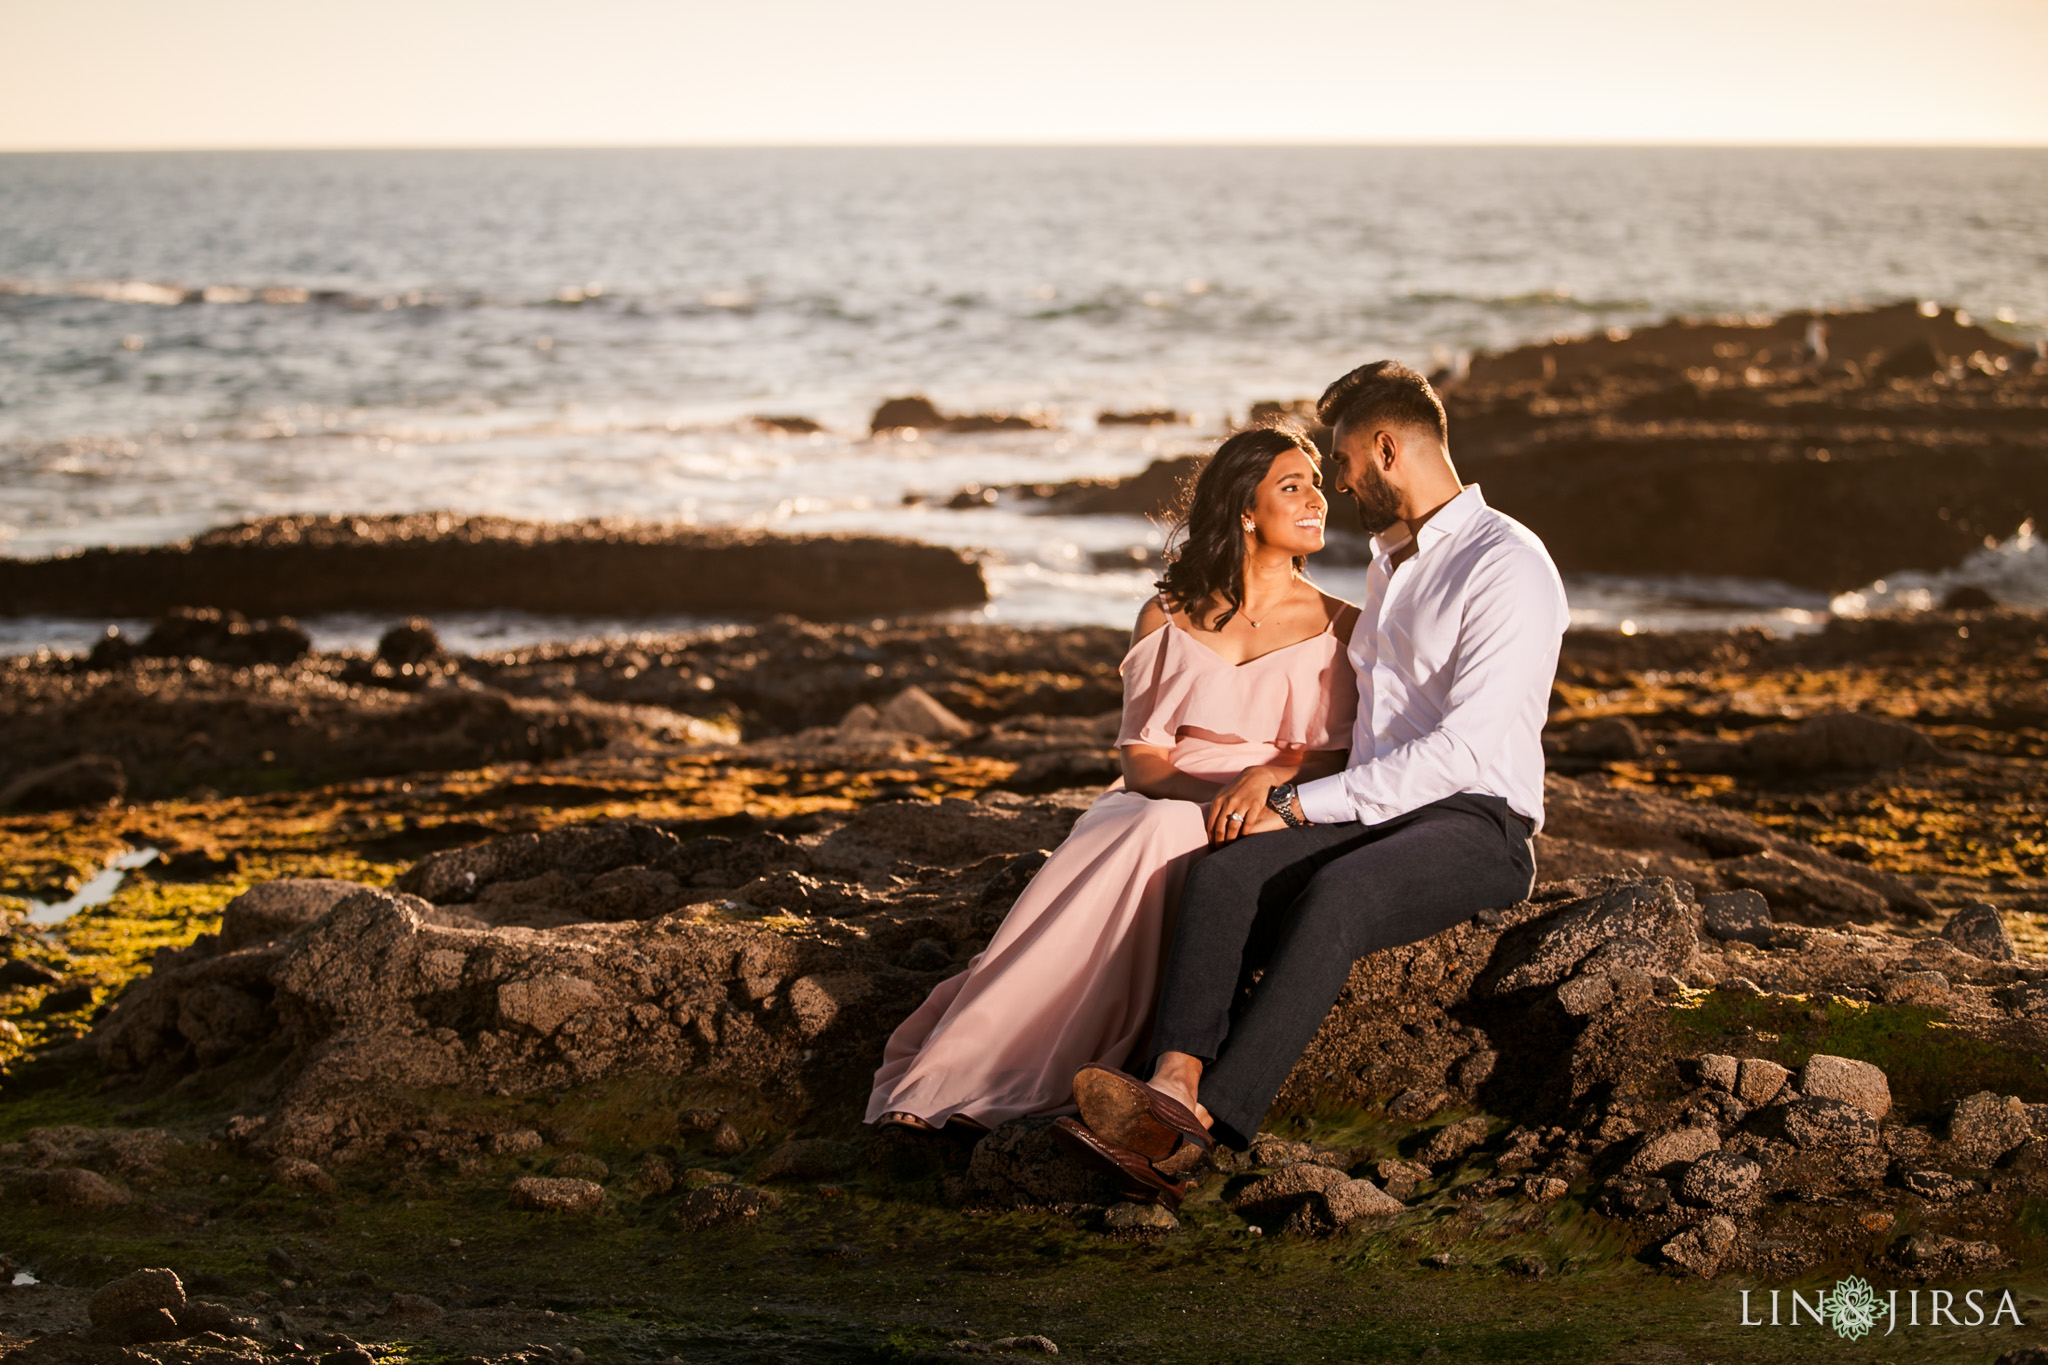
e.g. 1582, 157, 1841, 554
0, 147, 2048, 649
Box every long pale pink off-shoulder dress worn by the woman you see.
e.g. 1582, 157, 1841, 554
866, 622, 1358, 1128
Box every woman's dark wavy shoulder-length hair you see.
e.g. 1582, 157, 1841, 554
1157, 422, 1323, 630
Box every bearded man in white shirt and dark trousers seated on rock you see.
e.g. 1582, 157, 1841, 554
1069, 360, 1567, 1185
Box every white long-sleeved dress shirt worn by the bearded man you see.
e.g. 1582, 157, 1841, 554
1296, 483, 1571, 827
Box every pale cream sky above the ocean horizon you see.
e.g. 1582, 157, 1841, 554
0, 0, 2048, 151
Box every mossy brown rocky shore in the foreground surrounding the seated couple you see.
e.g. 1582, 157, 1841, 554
0, 610, 2048, 1361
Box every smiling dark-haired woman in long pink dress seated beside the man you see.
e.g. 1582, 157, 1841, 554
866, 428, 1358, 1130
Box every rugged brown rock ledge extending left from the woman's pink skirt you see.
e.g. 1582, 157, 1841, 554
81, 800, 1105, 1160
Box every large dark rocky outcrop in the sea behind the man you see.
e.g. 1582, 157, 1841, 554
954, 303, 2048, 591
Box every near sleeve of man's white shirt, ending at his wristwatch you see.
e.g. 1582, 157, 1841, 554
1296, 555, 1567, 825
